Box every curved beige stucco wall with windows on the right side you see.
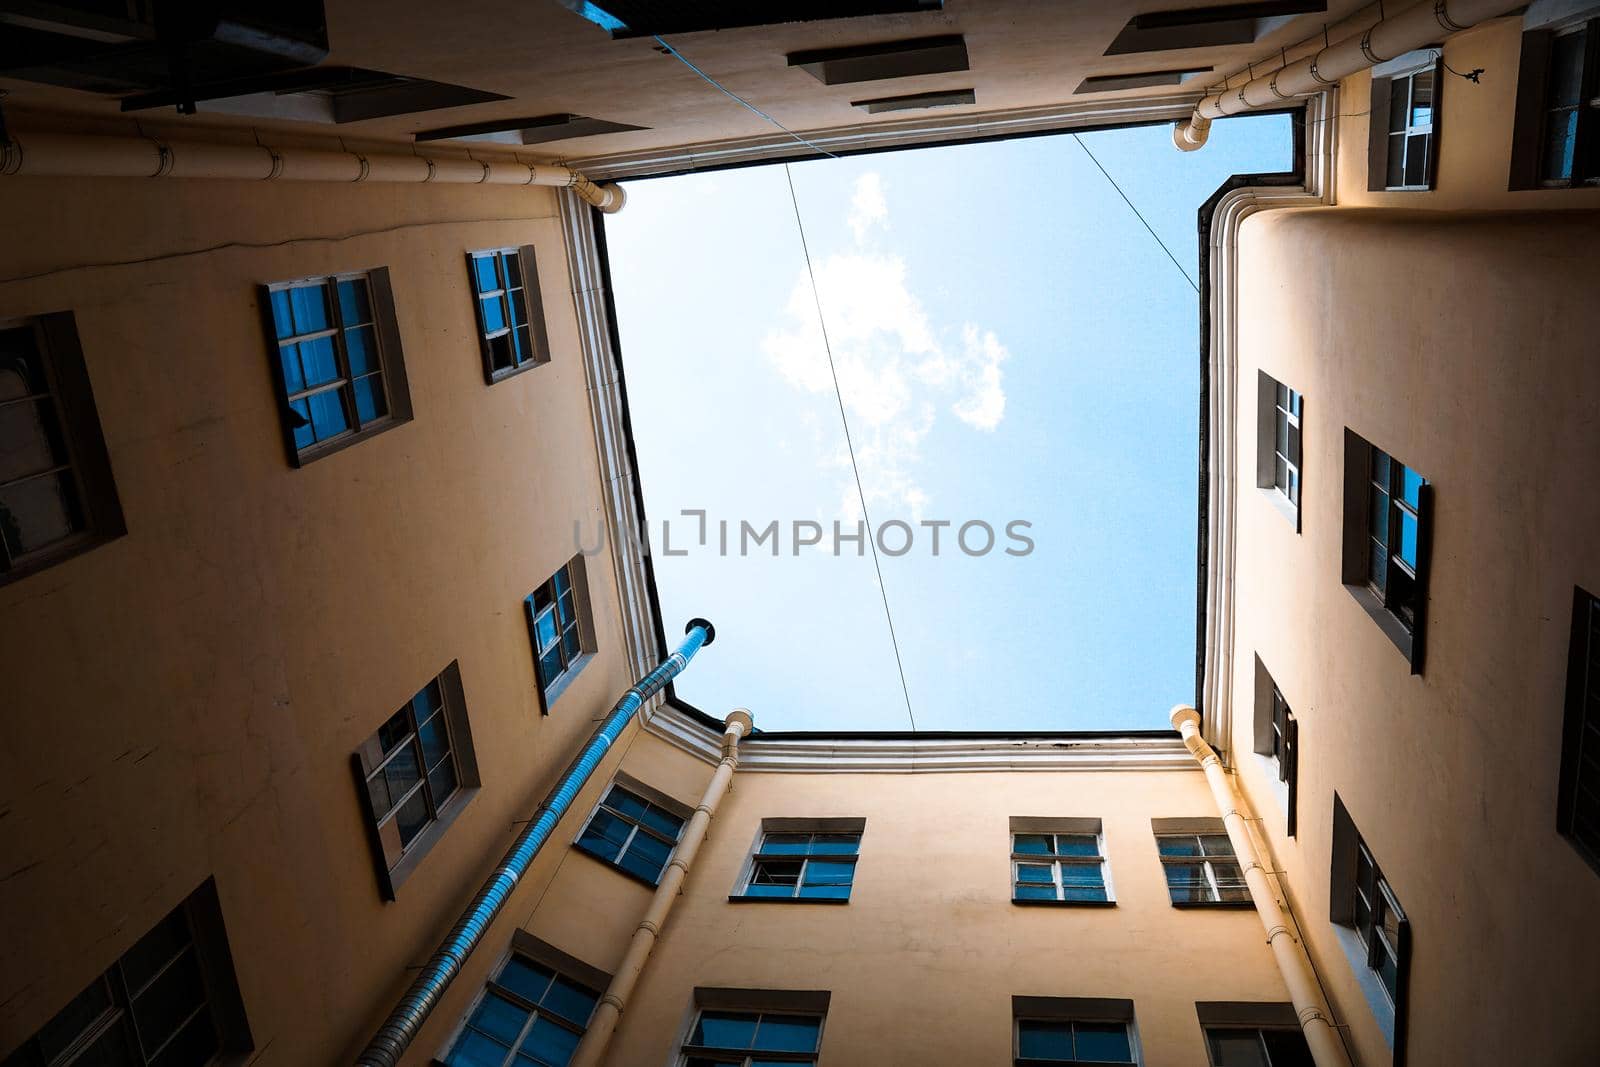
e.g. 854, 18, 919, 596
1234, 204, 1600, 1065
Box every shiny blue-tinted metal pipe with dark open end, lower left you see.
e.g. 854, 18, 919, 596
355, 619, 717, 1067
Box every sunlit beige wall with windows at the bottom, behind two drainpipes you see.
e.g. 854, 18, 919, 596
492, 735, 1286, 1067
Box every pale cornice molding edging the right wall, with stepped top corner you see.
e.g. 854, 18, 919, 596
1202, 86, 1339, 758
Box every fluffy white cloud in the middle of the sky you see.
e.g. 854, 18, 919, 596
762, 174, 1006, 520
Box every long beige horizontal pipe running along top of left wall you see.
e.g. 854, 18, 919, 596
0, 133, 624, 213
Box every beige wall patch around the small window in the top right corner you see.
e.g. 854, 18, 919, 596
1336, 18, 1600, 211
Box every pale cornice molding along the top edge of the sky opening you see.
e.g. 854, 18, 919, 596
562, 94, 1200, 181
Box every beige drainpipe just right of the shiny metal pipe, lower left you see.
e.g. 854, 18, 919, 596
568, 707, 752, 1067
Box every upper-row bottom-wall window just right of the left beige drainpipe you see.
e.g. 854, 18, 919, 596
730, 819, 866, 904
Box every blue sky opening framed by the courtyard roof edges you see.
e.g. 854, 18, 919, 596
605, 115, 1291, 731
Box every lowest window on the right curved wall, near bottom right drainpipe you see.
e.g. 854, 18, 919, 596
1330, 795, 1411, 1048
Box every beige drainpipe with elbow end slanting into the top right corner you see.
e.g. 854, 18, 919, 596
1173, 0, 1526, 152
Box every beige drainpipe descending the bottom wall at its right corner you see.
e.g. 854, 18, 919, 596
1173, 704, 1352, 1067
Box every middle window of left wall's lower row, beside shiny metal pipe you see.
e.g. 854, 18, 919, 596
354, 664, 478, 901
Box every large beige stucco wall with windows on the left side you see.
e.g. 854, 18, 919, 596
0, 171, 649, 1065
